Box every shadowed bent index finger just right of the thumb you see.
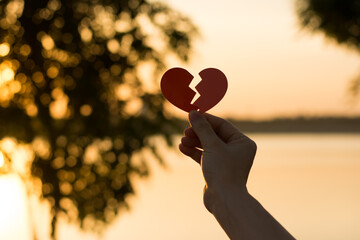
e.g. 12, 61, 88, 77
204, 113, 247, 143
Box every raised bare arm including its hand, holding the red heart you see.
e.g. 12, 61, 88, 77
179, 111, 294, 239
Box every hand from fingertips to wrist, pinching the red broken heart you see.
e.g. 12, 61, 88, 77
179, 111, 256, 212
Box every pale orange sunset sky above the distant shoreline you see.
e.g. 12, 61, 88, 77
164, 0, 360, 119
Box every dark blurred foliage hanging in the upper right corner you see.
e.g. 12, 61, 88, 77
297, 0, 360, 95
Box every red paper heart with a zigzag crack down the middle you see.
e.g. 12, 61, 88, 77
160, 68, 228, 113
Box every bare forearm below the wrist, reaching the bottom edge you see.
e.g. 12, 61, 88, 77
208, 190, 294, 240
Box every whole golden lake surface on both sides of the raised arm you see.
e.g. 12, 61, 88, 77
0, 134, 360, 240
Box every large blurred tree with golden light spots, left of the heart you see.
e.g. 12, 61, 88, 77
0, 0, 197, 238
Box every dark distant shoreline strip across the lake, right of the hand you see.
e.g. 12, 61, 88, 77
176, 117, 360, 133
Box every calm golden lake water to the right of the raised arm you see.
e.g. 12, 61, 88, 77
249, 134, 360, 239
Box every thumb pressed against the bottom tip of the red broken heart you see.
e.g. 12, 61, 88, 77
189, 110, 221, 150
